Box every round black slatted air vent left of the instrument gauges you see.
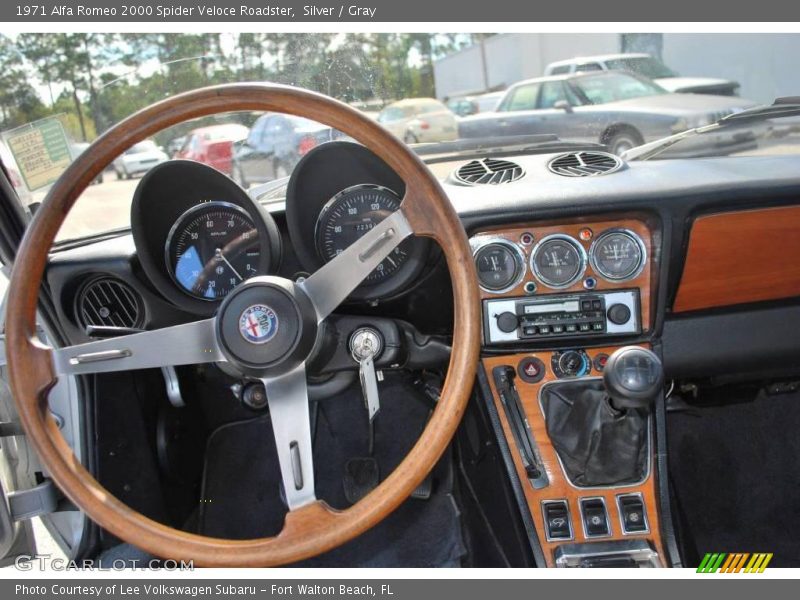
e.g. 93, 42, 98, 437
76, 276, 143, 327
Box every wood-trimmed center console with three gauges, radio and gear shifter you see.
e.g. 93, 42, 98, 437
471, 216, 665, 567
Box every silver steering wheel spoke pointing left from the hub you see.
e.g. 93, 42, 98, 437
53, 319, 225, 375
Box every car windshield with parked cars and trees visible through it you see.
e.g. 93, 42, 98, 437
0, 32, 800, 242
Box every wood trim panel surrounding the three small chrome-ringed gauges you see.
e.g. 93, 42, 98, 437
471, 218, 655, 331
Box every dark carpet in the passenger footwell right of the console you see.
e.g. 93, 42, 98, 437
667, 394, 800, 567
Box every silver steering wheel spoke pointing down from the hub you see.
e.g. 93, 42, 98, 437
261, 364, 317, 510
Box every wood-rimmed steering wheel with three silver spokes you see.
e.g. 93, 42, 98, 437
6, 84, 480, 567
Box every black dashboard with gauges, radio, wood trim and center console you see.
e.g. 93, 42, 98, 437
39, 141, 800, 565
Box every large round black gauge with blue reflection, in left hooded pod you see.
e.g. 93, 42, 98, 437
166, 202, 261, 300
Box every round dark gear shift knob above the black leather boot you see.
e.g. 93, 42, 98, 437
603, 346, 664, 410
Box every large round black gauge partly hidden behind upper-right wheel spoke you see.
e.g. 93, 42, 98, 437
316, 184, 411, 285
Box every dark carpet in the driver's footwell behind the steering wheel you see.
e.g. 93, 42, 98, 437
199, 374, 465, 567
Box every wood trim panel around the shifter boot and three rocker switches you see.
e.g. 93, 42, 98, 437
482, 346, 666, 567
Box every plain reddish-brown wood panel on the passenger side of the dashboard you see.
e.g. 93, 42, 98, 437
673, 206, 800, 312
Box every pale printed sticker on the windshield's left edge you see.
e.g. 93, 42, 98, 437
3, 117, 72, 191
